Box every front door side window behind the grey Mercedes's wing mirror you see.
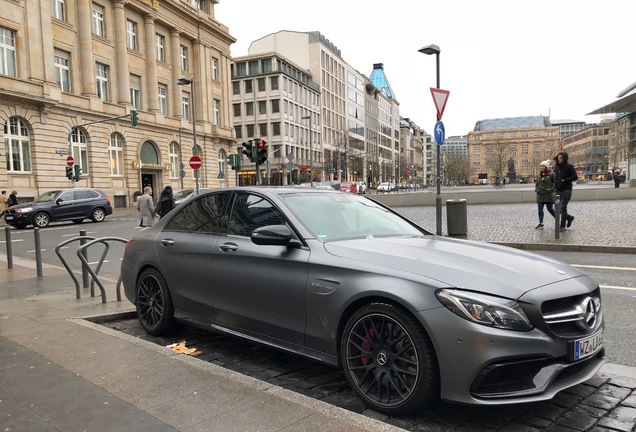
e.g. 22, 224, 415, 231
228, 193, 285, 237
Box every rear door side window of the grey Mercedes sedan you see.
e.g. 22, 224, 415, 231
164, 192, 230, 234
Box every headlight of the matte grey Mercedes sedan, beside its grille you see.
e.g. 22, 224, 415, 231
436, 289, 533, 331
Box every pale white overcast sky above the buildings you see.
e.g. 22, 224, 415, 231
215, 0, 636, 136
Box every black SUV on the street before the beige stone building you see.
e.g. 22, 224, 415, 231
4, 188, 113, 228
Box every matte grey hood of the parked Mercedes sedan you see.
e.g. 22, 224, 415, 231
324, 236, 584, 299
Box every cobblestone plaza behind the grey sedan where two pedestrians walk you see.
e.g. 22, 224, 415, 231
394, 197, 636, 247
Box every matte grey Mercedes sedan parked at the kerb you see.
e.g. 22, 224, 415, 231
122, 187, 604, 415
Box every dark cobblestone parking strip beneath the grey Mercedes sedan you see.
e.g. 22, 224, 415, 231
102, 313, 636, 432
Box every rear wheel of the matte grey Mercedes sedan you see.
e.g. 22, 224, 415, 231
135, 268, 174, 336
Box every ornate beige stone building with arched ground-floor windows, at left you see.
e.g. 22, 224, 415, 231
0, 0, 236, 207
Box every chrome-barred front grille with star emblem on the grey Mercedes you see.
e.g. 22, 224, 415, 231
541, 288, 603, 338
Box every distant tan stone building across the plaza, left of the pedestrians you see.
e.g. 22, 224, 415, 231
467, 116, 560, 184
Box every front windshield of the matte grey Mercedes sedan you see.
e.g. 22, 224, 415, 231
283, 193, 427, 241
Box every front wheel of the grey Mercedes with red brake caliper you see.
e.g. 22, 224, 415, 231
340, 303, 439, 415
